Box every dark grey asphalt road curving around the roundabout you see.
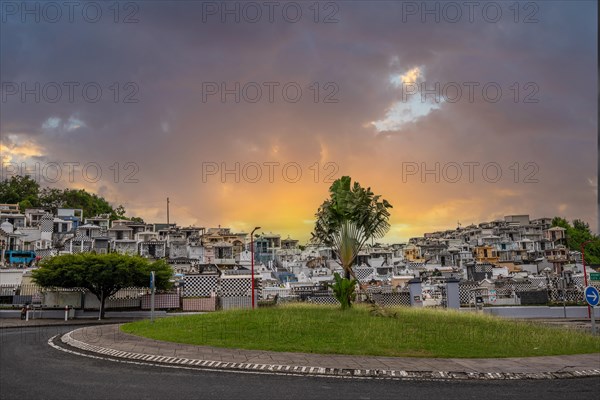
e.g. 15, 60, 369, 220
0, 326, 600, 400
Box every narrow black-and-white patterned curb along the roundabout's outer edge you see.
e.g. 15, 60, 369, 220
48, 331, 600, 381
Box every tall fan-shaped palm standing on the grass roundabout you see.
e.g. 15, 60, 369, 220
311, 176, 392, 279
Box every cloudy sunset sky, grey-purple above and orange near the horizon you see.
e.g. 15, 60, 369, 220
0, 1, 598, 243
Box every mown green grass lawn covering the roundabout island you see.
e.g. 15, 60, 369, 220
121, 304, 600, 358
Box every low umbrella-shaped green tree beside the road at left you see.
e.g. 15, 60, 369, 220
32, 253, 173, 318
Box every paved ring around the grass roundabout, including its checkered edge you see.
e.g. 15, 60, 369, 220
50, 324, 600, 380
